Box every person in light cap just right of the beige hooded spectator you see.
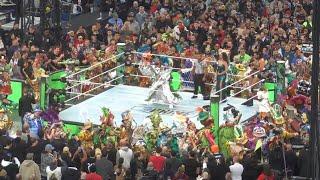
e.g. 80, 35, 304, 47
40, 144, 55, 177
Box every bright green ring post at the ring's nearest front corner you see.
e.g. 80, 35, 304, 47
210, 95, 220, 144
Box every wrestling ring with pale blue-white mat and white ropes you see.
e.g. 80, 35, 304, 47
59, 52, 272, 127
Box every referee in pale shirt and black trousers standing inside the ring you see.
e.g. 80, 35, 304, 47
192, 55, 206, 99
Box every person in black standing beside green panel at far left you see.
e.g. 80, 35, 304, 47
19, 89, 36, 126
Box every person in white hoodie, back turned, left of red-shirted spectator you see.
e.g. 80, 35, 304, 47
117, 139, 133, 170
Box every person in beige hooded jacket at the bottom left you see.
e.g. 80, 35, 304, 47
19, 153, 41, 180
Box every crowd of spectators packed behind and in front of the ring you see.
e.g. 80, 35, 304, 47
0, 0, 312, 180
